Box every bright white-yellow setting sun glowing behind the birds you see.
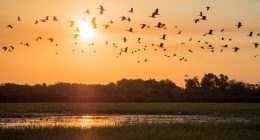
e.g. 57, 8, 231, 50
79, 21, 96, 41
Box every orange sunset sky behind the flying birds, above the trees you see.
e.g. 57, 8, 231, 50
0, 0, 260, 85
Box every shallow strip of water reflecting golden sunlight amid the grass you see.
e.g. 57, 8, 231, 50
0, 115, 249, 128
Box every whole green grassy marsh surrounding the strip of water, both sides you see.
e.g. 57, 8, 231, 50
0, 103, 260, 140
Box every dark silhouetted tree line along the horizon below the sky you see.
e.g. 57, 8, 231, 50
0, 73, 260, 103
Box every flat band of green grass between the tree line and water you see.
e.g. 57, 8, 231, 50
0, 103, 260, 117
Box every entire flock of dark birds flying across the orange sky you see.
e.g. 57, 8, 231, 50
2, 5, 260, 63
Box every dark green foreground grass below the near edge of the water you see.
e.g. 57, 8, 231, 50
0, 122, 260, 140
